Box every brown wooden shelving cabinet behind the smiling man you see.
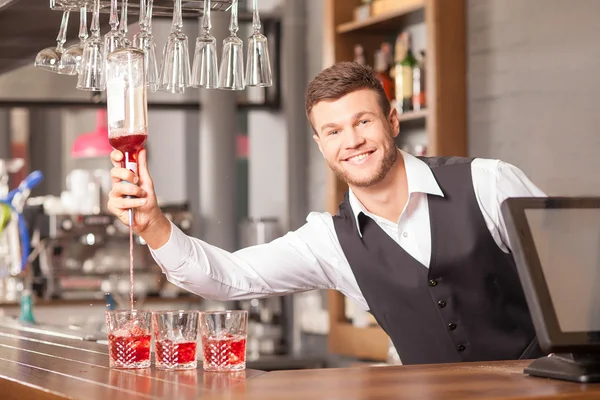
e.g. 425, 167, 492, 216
323, 0, 467, 361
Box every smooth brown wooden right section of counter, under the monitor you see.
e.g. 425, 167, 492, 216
214, 360, 600, 400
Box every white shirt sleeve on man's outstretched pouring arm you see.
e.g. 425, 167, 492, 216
151, 213, 339, 300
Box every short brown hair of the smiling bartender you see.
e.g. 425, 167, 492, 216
305, 61, 390, 125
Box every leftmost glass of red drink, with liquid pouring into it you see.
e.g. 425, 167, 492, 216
106, 310, 152, 368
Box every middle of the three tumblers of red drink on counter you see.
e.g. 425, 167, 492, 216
152, 310, 198, 370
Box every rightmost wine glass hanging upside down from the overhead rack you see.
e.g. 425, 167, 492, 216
246, 0, 273, 87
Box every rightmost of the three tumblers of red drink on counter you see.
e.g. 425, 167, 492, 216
200, 310, 248, 372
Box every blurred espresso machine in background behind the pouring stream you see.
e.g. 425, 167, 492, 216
29, 204, 192, 300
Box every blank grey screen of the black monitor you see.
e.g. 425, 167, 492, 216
524, 208, 600, 333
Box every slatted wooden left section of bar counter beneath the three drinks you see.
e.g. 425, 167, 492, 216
0, 327, 263, 400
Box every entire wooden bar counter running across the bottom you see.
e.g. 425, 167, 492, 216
0, 327, 600, 400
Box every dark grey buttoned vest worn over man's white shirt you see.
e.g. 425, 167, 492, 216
333, 157, 542, 364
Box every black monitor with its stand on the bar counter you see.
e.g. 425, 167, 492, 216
501, 197, 600, 382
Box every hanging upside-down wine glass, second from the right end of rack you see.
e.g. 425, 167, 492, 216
219, 0, 244, 90
